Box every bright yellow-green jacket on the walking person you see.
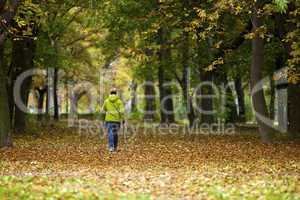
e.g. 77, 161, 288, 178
102, 94, 125, 122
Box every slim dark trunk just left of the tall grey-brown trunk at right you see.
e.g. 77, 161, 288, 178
234, 76, 246, 122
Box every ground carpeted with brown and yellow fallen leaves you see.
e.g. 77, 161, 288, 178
0, 126, 300, 199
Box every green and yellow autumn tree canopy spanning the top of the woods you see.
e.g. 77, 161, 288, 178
1, 0, 300, 125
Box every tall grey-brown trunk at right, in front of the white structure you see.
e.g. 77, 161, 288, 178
251, 10, 272, 143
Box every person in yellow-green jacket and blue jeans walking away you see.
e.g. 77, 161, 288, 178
102, 88, 125, 152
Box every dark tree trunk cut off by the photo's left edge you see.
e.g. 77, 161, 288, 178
0, 46, 12, 148
